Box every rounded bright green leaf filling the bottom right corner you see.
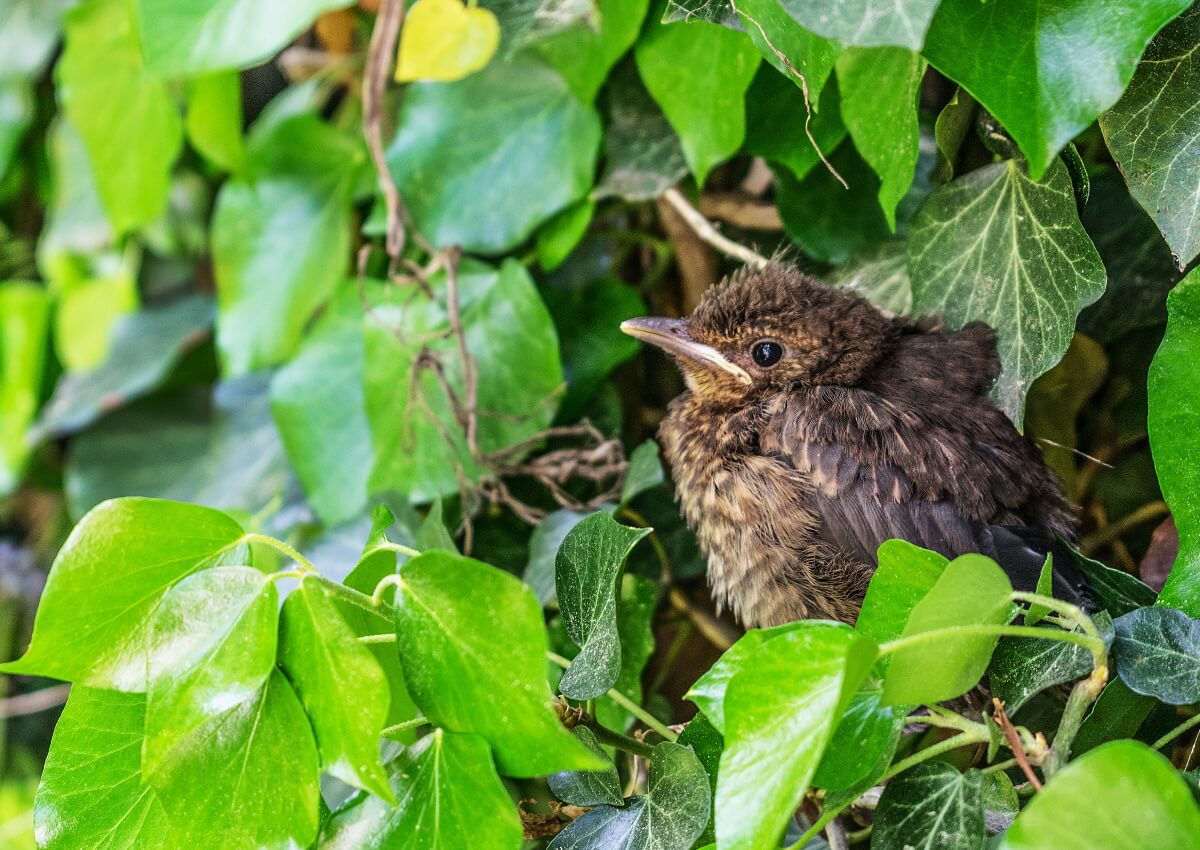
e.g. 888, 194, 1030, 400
1000, 741, 1200, 850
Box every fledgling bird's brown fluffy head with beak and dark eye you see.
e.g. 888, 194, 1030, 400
620, 263, 896, 402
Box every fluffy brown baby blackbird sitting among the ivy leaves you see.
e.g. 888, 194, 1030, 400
620, 263, 1085, 627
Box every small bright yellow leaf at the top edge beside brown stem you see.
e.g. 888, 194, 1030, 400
396, 0, 500, 83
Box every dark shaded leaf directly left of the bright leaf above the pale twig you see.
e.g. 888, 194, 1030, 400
592, 64, 688, 200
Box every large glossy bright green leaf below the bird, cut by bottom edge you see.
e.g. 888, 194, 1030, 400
706, 622, 876, 850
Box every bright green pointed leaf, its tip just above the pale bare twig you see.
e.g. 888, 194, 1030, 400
634, 14, 758, 186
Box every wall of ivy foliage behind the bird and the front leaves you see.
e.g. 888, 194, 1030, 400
0, 0, 1200, 846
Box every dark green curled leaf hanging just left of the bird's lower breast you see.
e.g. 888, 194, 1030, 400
554, 510, 653, 700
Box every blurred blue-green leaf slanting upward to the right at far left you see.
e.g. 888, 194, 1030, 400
37, 295, 212, 437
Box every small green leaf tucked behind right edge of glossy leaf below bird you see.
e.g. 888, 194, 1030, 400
812, 687, 906, 791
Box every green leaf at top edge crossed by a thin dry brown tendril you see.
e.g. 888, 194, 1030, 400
737, 0, 841, 99
